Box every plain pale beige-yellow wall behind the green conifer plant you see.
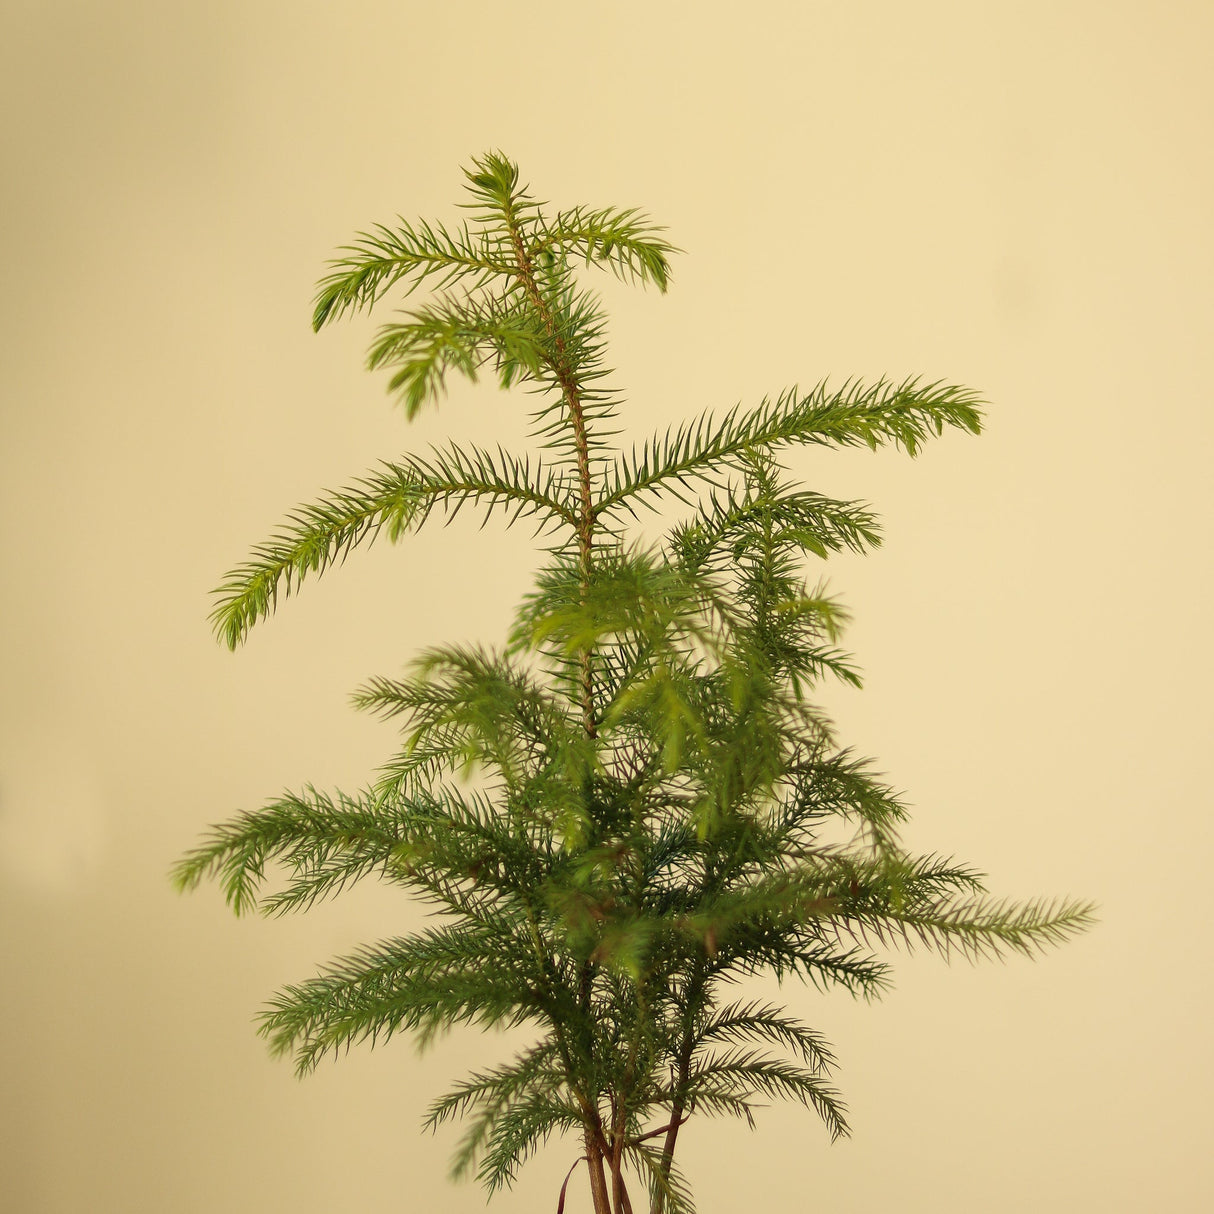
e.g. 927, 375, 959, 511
0, 0, 1214, 1214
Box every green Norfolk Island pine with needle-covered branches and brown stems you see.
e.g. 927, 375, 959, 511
175, 154, 1091, 1214
